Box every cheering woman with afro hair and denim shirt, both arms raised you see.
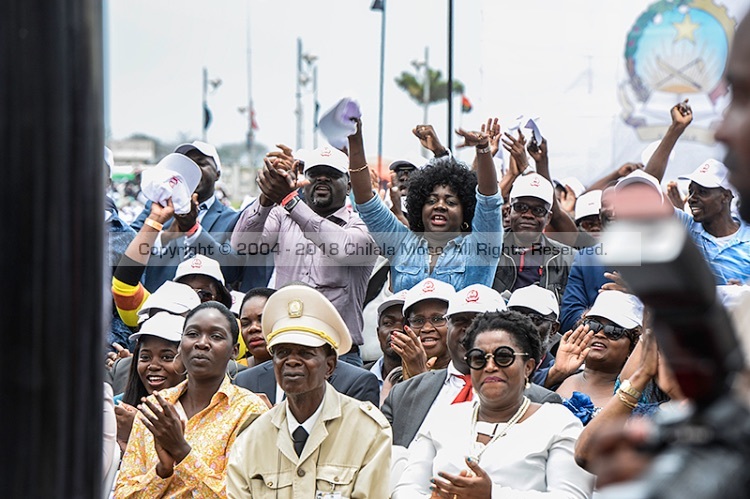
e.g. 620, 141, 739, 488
349, 120, 503, 293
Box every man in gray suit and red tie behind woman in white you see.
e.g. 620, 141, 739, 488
380, 284, 562, 447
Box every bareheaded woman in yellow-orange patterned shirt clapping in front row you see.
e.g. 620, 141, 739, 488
115, 301, 268, 497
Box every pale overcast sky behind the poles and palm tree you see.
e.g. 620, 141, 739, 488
105, 0, 750, 184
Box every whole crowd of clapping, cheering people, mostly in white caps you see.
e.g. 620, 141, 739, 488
103, 13, 750, 499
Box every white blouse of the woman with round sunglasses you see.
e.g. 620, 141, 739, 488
391, 402, 594, 499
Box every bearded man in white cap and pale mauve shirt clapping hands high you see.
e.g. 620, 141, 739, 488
232, 146, 377, 367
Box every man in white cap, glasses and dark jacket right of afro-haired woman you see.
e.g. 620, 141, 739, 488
492, 173, 575, 302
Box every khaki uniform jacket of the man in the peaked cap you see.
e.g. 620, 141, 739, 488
227, 385, 391, 499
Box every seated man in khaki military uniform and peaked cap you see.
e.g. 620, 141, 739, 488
227, 285, 391, 499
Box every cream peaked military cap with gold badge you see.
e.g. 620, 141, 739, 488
261, 284, 352, 355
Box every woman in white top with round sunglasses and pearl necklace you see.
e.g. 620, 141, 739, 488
392, 310, 594, 499
